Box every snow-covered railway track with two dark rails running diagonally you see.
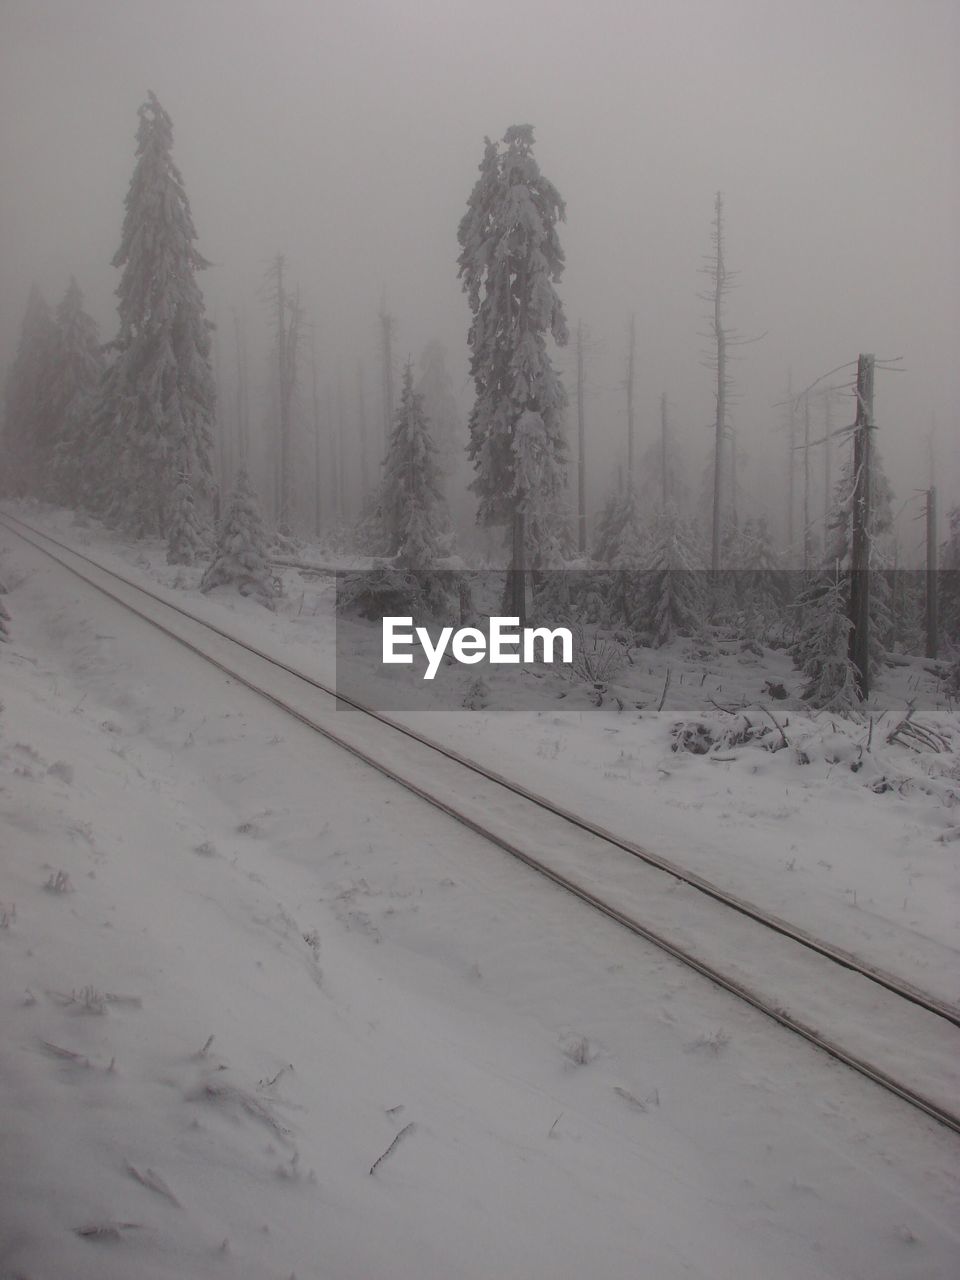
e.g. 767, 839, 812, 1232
0, 513, 960, 1133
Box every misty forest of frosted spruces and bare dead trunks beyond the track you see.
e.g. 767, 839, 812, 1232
3, 92, 960, 712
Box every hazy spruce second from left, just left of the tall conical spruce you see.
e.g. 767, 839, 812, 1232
46, 276, 105, 507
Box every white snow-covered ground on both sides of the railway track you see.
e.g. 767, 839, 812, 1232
0, 511, 960, 1280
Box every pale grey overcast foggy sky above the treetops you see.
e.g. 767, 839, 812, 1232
0, 0, 960, 529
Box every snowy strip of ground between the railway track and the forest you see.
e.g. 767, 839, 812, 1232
16, 507, 960, 1002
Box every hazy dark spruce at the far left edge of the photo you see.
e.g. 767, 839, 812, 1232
0, 285, 55, 498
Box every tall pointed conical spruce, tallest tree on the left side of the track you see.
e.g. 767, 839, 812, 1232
95, 93, 215, 538
